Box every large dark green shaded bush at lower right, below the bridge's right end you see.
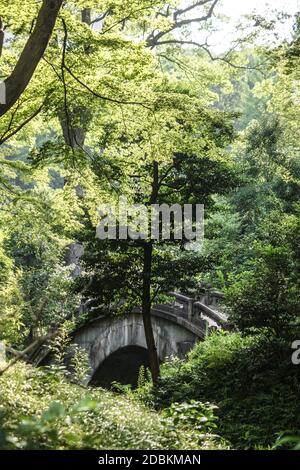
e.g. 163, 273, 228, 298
144, 331, 300, 449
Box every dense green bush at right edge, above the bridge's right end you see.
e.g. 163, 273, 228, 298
226, 212, 300, 337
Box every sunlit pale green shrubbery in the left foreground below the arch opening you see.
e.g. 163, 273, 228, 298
0, 364, 220, 450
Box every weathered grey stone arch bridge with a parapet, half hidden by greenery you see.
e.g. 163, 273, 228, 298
69, 292, 226, 384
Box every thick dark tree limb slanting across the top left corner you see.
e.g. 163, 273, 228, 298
0, 0, 63, 116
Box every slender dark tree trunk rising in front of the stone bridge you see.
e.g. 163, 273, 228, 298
142, 242, 159, 385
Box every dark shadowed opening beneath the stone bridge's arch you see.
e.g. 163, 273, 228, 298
90, 346, 149, 389
